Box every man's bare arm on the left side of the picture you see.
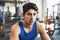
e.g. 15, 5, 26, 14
10, 24, 19, 40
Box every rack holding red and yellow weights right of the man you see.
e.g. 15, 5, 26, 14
44, 8, 55, 35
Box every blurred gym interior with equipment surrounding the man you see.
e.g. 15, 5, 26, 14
0, 0, 60, 40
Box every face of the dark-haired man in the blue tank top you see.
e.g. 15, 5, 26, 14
24, 9, 37, 25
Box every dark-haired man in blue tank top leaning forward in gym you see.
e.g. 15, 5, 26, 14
10, 3, 50, 40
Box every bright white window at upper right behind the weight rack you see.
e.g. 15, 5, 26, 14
46, 0, 59, 17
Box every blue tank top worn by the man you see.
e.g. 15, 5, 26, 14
18, 21, 37, 40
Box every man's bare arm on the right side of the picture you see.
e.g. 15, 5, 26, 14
37, 23, 51, 40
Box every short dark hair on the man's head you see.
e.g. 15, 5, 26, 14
23, 2, 38, 14
